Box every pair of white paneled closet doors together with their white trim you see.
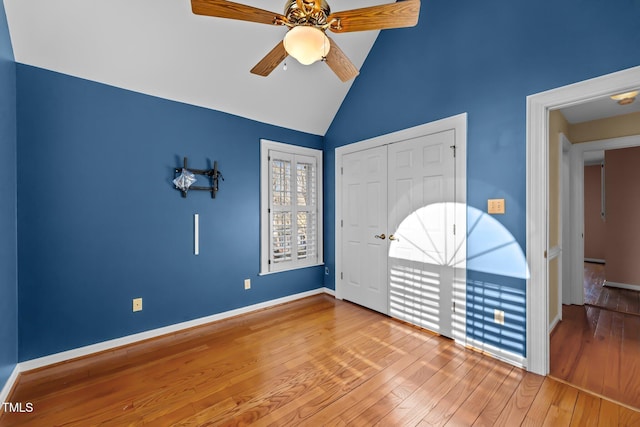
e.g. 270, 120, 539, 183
336, 114, 466, 340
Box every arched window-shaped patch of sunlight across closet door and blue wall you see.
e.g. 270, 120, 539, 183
389, 203, 529, 342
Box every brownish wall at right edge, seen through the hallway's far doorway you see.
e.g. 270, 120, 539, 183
604, 147, 640, 285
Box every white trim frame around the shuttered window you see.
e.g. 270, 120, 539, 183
259, 139, 324, 275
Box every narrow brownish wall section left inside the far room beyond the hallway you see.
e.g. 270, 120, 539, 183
584, 165, 607, 260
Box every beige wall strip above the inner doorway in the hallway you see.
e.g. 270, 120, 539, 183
568, 112, 640, 144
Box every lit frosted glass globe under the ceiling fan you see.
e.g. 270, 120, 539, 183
283, 25, 331, 65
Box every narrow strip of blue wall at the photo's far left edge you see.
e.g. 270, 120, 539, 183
0, 2, 18, 390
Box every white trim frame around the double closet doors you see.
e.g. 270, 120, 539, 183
334, 113, 467, 343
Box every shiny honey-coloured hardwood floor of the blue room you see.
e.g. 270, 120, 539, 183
0, 295, 640, 426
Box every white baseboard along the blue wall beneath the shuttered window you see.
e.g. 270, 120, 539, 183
17, 288, 334, 374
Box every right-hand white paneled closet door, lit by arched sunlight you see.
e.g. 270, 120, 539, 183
388, 130, 456, 337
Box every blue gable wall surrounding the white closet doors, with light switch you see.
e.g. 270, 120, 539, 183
325, 0, 640, 355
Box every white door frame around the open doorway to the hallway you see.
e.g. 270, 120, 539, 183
526, 66, 640, 375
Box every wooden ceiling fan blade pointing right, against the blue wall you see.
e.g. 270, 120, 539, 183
328, 0, 420, 33
